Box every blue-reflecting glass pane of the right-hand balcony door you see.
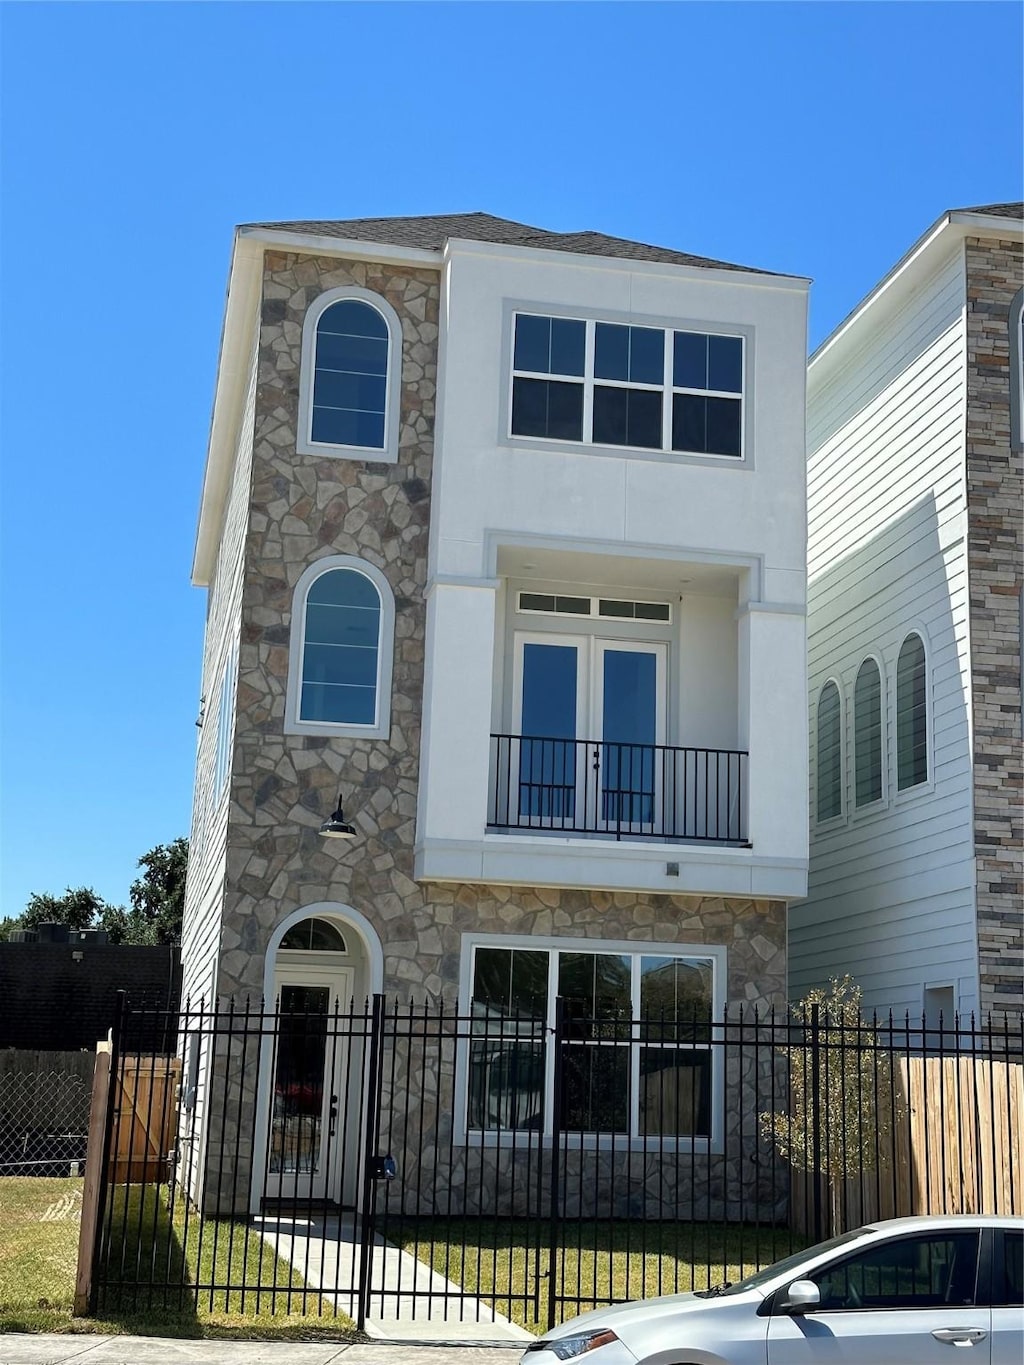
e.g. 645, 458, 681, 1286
601, 650, 658, 824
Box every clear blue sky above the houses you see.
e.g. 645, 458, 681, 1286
0, 0, 1024, 915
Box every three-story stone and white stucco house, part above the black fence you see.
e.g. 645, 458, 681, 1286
183, 214, 807, 1193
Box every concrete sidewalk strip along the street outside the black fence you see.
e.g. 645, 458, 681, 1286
0, 1332, 522, 1365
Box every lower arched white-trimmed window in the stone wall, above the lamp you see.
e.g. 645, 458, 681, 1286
284, 554, 395, 740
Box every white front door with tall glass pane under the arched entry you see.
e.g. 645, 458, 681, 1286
266, 964, 354, 1201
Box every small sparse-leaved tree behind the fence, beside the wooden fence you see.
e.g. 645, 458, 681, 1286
759, 976, 902, 1182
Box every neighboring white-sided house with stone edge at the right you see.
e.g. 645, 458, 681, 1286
789, 203, 1024, 1020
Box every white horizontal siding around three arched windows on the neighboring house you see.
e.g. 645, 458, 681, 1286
789, 240, 978, 1013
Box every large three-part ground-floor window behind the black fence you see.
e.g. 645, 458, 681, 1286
461, 934, 725, 1151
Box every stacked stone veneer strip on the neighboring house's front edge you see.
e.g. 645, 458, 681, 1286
967, 238, 1024, 1011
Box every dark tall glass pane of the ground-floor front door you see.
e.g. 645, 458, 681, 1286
270, 986, 330, 1175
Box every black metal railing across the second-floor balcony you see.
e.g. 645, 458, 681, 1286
487, 734, 748, 844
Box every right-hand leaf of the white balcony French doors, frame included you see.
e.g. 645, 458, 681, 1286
595, 640, 665, 833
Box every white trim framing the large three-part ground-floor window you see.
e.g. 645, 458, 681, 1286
453, 932, 728, 1156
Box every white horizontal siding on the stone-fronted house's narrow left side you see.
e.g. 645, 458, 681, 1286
182, 331, 257, 1003
